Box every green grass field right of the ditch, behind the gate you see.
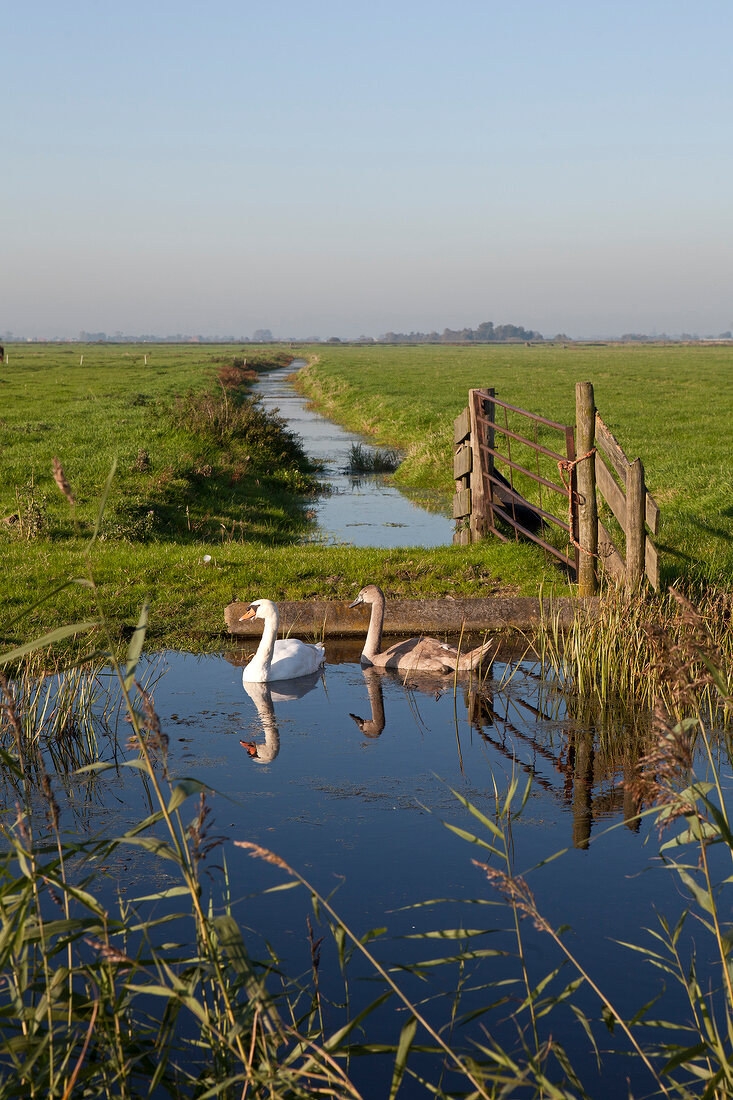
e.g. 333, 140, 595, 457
298, 344, 733, 587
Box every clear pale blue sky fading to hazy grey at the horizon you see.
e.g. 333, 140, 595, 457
0, 0, 733, 339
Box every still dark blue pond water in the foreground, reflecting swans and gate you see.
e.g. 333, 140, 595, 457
59, 644, 708, 1098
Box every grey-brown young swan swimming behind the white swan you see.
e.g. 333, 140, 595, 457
349, 584, 493, 672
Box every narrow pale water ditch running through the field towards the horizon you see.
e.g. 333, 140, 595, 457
252, 360, 453, 548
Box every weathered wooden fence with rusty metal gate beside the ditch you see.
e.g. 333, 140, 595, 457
453, 382, 659, 595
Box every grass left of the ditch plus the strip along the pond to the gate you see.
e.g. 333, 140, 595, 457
0, 344, 568, 647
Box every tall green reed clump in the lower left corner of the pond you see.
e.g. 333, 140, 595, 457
0, 486, 365, 1098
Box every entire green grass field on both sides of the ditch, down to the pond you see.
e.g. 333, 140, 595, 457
0, 344, 733, 646
